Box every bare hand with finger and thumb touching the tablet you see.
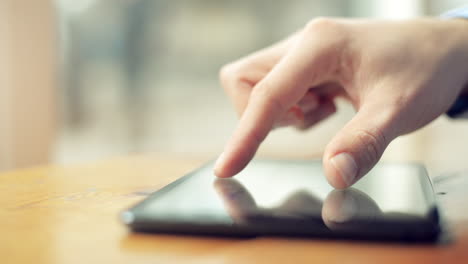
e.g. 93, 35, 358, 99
215, 18, 468, 189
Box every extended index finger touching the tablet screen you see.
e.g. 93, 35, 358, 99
215, 34, 326, 177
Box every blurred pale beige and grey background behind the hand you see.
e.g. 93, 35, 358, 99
0, 0, 468, 175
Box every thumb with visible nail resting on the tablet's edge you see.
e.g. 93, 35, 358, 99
323, 104, 395, 189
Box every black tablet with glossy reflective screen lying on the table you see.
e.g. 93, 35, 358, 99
121, 160, 440, 241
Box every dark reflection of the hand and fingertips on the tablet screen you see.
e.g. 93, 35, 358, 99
214, 178, 434, 234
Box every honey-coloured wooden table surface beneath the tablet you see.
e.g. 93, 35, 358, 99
0, 156, 468, 264
